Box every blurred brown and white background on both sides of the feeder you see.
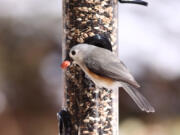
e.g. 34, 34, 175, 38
0, 0, 180, 135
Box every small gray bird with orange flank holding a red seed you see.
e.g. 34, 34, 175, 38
63, 44, 155, 112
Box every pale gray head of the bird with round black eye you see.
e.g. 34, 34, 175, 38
69, 44, 94, 63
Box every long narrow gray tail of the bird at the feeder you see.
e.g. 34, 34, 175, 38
123, 83, 155, 113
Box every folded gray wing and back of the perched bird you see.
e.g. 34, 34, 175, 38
84, 48, 140, 87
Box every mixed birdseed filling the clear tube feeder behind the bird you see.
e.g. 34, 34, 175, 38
63, 0, 118, 135
